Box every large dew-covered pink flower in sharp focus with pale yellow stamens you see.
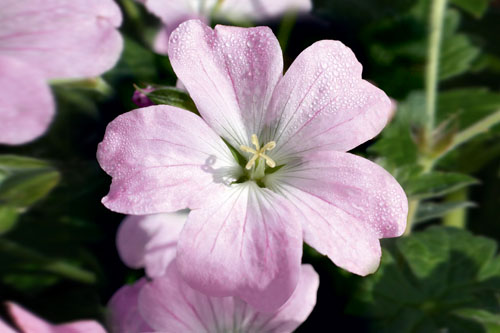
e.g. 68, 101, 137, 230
97, 20, 408, 311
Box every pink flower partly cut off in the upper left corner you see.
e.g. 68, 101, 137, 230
0, 0, 123, 144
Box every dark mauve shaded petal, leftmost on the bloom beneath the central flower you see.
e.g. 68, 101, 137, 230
108, 278, 152, 333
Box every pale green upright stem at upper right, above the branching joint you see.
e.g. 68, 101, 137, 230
424, 0, 446, 146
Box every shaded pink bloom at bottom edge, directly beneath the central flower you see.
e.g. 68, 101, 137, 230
108, 261, 319, 333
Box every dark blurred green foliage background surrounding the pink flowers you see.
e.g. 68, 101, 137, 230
0, 0, 500, 333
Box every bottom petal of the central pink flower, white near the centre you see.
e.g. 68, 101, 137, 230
177, 182, 302, 312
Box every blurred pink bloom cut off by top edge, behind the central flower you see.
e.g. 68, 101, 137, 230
138, 0, 312, 54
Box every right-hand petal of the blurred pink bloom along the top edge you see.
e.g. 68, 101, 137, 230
217, 0, 312, 20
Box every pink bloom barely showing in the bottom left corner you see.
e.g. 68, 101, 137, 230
0, 302, 106, 333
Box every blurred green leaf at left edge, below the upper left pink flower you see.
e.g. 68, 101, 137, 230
0, 155, 60, 209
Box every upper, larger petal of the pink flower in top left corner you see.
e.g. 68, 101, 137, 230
0, 0, 123, 78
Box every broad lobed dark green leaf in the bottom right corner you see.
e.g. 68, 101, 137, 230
349, 227, 500, 333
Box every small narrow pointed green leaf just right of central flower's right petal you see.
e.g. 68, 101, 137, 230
405, 171, 478, 199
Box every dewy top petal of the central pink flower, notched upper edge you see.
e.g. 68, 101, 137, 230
168, 20, 283, 147
